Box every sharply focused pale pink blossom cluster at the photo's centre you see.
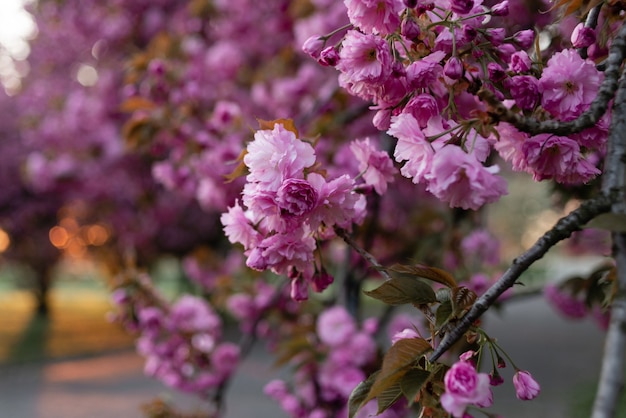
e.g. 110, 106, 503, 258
221, 123, 365, 300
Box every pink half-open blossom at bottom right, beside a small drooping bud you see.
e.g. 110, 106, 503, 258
441, 361, 493, 418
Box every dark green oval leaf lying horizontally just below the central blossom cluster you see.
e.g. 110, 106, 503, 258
365, 277, 437, 305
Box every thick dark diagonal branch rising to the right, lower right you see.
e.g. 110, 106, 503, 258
429, 195, 613, 362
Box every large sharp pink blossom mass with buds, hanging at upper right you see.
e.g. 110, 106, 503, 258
303, 0, 608, 210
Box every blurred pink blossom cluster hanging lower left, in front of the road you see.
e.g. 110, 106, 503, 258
112, 277, 240, 396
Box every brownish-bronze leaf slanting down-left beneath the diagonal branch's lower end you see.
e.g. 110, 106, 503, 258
364, 338, 432, 403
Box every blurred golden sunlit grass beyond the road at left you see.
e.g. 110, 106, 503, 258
0, 281, 133, 363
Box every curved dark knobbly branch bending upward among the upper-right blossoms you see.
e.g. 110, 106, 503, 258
478, 22, 626, 135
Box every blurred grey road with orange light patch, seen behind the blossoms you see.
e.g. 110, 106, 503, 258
0, 298, 626, 418
